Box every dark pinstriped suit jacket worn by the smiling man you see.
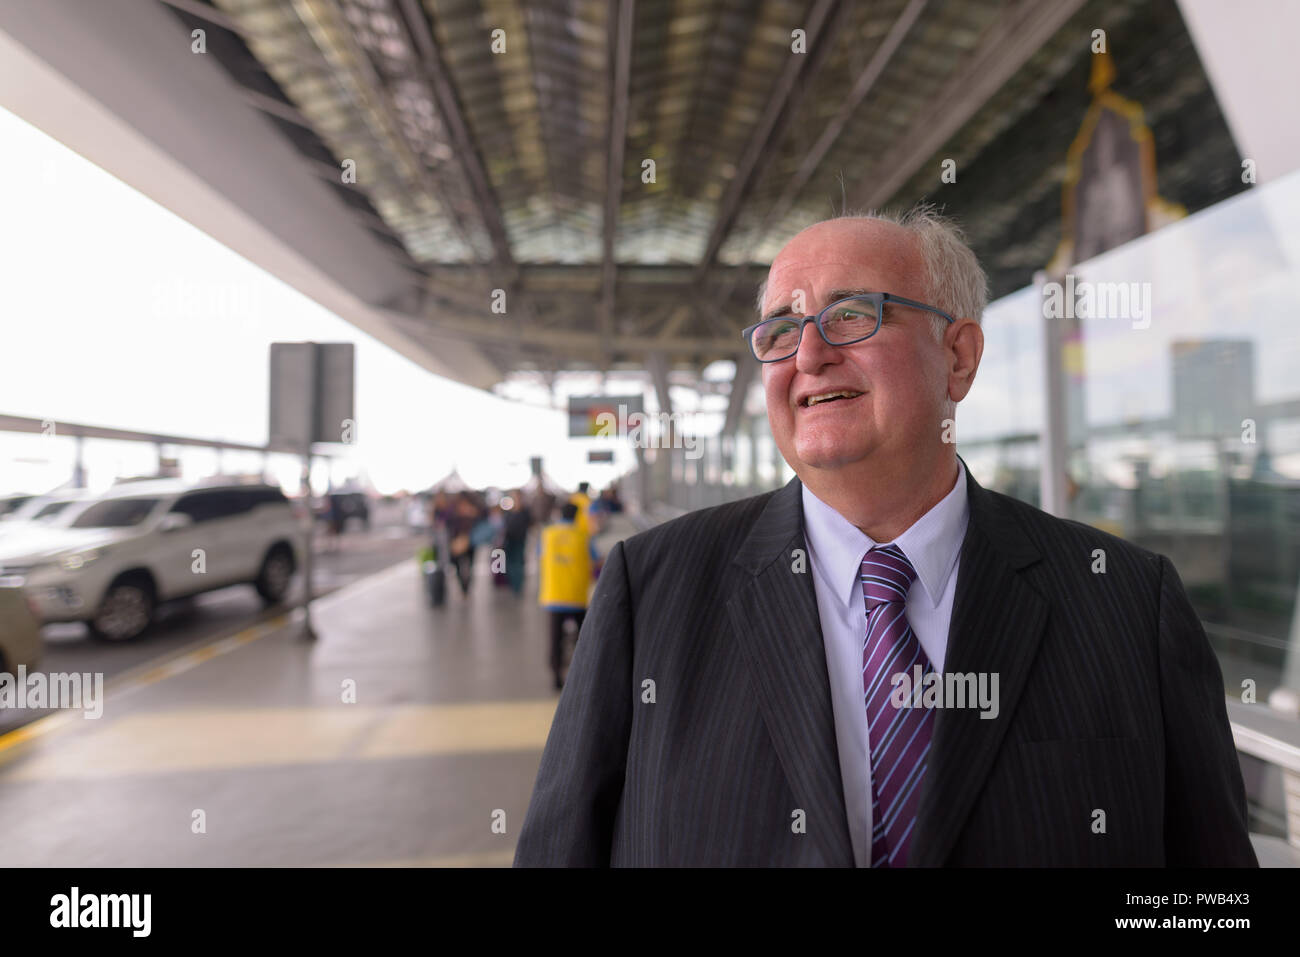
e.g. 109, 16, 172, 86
515, 462, 1257, 866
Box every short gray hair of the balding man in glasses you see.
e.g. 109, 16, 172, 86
757, 203, 988, 338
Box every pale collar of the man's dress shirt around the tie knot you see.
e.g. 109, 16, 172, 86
803, 459, 970, 607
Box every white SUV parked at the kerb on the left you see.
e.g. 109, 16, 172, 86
0, 480, 304, 641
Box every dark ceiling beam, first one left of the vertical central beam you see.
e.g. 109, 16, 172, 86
397, 0, 517, 273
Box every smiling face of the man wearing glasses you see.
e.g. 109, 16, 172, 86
762, 220, 948, 477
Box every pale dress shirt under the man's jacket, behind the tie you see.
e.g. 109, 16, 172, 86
803, 459, 970, 867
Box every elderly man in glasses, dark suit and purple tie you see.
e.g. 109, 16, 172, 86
516, 209, 1256, 867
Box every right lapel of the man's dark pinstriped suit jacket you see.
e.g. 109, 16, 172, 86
907, 471, 1048, 867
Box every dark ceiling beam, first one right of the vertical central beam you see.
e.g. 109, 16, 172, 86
696, 0, 845, 283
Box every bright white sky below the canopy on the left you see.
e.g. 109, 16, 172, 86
0, 109, 676, 494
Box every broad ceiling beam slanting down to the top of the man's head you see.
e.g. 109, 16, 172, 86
850, 0, 1083, 209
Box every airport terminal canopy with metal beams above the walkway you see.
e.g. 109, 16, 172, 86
0, 0, 1242, 387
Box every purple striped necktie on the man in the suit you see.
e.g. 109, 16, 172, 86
861, 545, 933, 867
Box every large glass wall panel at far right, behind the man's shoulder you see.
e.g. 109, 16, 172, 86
1066, 167, 1300, 701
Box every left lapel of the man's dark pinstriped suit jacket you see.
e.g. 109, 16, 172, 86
727, 479, 854, 867
